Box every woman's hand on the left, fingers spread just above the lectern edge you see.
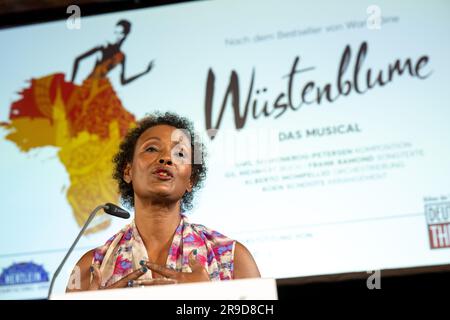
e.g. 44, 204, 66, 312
88, 265, 177, 290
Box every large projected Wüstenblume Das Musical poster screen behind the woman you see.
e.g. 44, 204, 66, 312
0, 1, 450, 299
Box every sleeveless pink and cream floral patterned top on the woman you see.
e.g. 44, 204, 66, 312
93, 215, 236, 286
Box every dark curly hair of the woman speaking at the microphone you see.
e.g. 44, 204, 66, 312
113, 112, 207, 212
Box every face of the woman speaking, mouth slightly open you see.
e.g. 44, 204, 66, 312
124, 125, 192, 208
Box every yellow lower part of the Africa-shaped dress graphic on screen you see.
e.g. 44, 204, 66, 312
53, 88, 126, 234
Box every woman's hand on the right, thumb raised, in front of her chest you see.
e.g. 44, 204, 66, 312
146, 249, 211, 283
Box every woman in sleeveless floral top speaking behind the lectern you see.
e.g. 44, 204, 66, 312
67, 113, 260, 292
